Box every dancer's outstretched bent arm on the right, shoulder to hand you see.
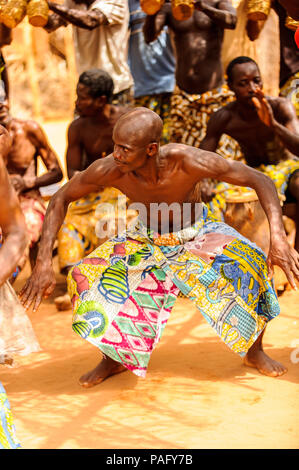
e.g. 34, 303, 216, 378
187, 149, 299, 289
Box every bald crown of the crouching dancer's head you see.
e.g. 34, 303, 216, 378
115, 107, 163, 145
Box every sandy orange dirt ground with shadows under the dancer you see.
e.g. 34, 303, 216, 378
0, 123, 299, 449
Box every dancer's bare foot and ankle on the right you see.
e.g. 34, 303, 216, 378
244, 330, 287, 377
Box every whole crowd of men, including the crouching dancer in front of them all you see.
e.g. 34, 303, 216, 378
0, 0, 299, 448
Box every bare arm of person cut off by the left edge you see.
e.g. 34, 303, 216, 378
0, 156, 28, 285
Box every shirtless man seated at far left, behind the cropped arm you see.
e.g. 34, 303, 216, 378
0, 99, 62, 278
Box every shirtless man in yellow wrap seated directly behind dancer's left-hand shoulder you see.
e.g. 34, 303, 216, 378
55, 69, 134, 310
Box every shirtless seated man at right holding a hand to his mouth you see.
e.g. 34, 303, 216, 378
201, 56, 299, 251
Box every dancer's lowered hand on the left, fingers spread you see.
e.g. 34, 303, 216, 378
19, 263, 56, 312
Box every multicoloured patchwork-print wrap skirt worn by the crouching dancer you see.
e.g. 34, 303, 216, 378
68, 204, 279, 377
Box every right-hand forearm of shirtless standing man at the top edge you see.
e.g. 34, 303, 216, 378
194, 0, 237, 29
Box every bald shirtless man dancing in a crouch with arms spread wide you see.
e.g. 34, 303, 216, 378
20, 108, 299, 387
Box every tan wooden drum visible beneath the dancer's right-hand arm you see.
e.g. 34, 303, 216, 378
224, 187, 270, 254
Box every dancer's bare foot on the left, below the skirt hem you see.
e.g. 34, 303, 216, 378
79, 357, 128, 388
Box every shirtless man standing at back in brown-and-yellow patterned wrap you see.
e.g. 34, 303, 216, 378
143, 0, 241, 159
